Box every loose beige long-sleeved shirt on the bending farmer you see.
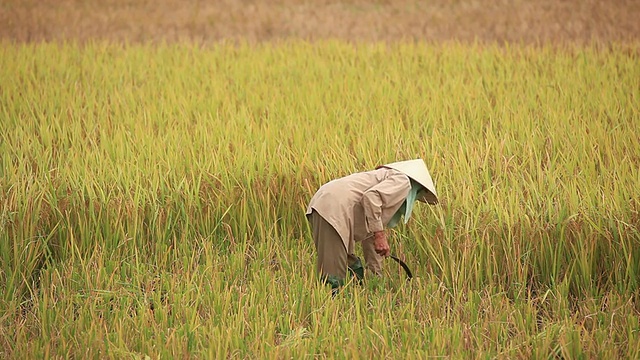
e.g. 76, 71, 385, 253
307, 168, 411, 249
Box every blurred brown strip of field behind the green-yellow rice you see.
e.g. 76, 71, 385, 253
0, 0, 640, 44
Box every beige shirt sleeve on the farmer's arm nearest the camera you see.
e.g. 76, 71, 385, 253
361, 171, 411, 233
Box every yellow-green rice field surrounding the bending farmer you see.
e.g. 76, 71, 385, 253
0, 40, 640, 359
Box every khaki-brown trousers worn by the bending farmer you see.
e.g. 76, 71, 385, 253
309, 211, 384, 279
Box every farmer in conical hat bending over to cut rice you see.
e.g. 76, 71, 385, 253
306, 159, 438, 290
